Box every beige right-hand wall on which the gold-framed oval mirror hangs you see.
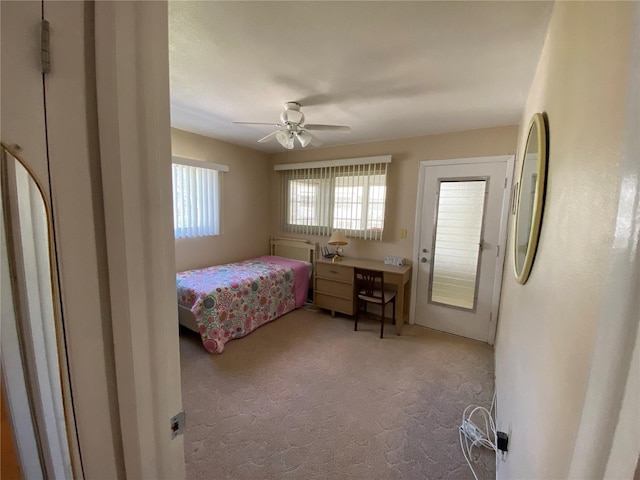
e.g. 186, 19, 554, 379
496, 2, 637, 478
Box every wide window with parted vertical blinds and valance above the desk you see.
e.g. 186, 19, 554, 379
275, 156, 391, 240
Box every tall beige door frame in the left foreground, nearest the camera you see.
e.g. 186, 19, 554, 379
94, 1, 186, 480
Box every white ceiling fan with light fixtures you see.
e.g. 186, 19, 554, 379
233, 102, 351, 150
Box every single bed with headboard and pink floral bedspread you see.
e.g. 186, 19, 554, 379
176, 238, 316, 353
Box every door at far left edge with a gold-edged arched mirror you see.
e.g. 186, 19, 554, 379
0, 1, 74, 478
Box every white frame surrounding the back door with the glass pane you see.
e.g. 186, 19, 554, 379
409, 155, 515, 345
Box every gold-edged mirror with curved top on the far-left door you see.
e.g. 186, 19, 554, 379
0, 143, 77, 478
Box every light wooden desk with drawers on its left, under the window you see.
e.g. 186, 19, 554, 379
313, 257, 411, 335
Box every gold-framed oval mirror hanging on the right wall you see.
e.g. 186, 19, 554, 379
513, 113, 547, 284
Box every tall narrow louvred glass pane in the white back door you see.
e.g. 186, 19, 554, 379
429, 179, 488, 310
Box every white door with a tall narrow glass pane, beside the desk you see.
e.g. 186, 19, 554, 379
414, 157, 513, 343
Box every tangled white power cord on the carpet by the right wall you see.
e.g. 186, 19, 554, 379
459, 394, 498, 480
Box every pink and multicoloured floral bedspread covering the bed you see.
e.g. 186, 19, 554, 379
177, 259, 296, 353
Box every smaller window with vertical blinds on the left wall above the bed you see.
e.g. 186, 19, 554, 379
172, 157, 229, 238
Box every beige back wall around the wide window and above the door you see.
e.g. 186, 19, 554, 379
270, 126, 518, 260
